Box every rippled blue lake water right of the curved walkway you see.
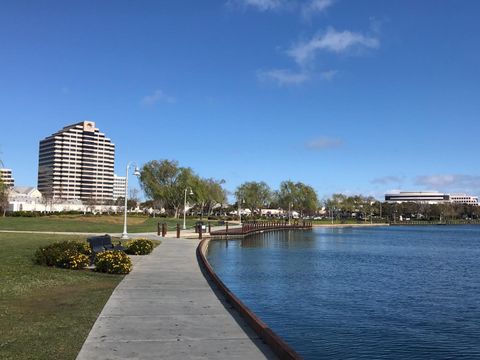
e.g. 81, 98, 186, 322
208, 226, 480, 359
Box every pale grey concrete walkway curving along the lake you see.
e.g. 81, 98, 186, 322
77, 237, 276, 360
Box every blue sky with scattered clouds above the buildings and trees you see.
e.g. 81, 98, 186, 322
0, 0, 480, 198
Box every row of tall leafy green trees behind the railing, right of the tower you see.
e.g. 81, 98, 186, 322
140, 160, 319, 217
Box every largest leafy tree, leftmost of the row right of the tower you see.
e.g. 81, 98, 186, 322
140, 160, 196, 218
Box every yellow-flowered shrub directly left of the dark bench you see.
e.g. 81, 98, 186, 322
34, 241, 91, 269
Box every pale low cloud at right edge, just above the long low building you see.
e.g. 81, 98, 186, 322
414, 174, 480, 191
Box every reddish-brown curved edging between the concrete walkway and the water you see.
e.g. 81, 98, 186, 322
197, 239, 302, 360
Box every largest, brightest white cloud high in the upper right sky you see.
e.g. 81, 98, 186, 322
287, 28, 380, 65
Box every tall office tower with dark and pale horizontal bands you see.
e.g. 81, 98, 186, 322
38, 121, 115, 203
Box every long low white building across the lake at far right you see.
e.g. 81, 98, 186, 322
385, 191, 478, 205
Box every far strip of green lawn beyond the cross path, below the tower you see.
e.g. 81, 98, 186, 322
0, 215, 201, 233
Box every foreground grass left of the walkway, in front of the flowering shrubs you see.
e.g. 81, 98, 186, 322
0, 234, 123, 360
